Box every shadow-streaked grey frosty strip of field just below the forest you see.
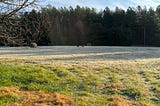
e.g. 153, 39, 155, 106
0, 46, 160, 61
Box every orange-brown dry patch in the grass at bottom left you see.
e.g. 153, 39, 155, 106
0, 87, 72, 106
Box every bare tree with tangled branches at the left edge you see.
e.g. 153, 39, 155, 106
0, 0, 37, 45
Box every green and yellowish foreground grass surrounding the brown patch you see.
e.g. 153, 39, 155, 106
0, 63, 160, 106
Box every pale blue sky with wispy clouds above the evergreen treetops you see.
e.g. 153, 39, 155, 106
41, 0, 160, 10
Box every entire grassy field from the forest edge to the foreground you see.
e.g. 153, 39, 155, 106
0, 47, 160, 106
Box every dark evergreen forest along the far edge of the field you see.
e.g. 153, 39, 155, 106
0, 5, 160, 46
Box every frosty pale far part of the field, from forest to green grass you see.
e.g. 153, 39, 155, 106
0, 46, 160, 67
